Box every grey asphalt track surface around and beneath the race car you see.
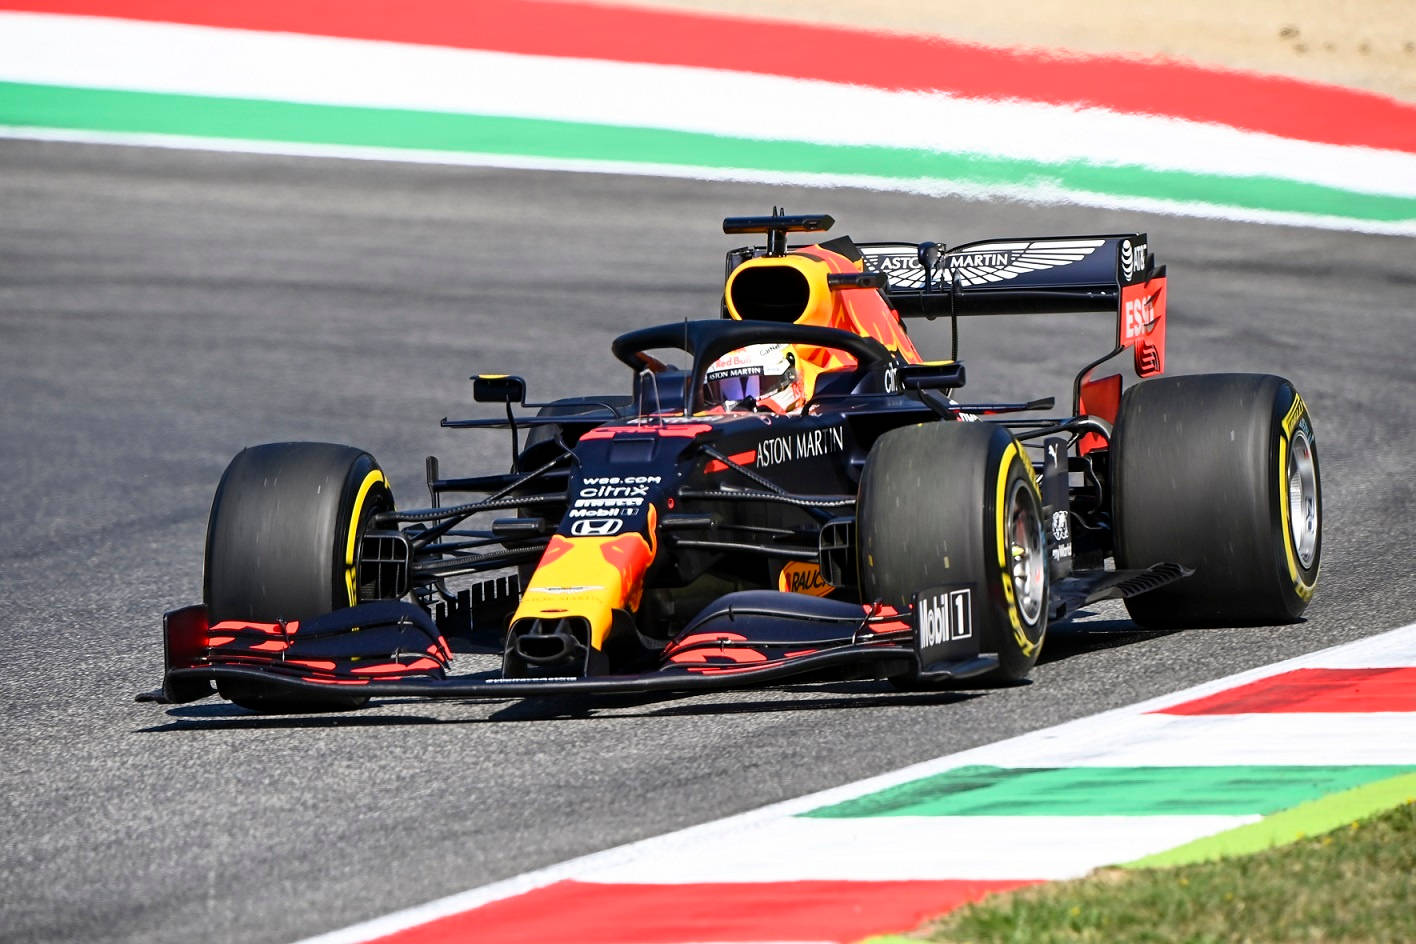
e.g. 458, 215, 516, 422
0, 140, 1416, 943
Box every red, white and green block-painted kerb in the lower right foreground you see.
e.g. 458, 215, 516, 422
303, 624, 1416, 944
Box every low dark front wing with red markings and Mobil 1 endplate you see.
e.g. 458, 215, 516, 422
143, 586, 998, 703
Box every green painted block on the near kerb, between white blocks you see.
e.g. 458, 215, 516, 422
801, 766, 1416, 819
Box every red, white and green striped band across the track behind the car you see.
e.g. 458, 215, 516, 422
0, 0, 1416, 235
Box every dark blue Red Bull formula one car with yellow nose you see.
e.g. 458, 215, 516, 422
153, 211, 1321, 710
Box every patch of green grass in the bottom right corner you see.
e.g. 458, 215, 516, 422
875, 802, 1416, 944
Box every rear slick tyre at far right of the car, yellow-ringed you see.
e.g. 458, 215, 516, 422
1112, 374, 1323, 627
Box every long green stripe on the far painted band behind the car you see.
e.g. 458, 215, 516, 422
0, 82, 1416, 222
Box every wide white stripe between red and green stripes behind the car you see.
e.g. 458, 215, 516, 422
0, 13, 1416, 197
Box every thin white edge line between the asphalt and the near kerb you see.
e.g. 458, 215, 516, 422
300, 623, 1416, 944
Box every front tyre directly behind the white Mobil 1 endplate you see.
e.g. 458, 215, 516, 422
857, 423, 1048, 682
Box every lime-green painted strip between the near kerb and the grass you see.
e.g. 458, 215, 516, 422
1121, 774, 1416, 869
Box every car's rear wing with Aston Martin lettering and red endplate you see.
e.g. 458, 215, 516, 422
857, 234, 1165, 376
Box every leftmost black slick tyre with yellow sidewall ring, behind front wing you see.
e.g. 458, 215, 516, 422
202, 443, 394, 712
